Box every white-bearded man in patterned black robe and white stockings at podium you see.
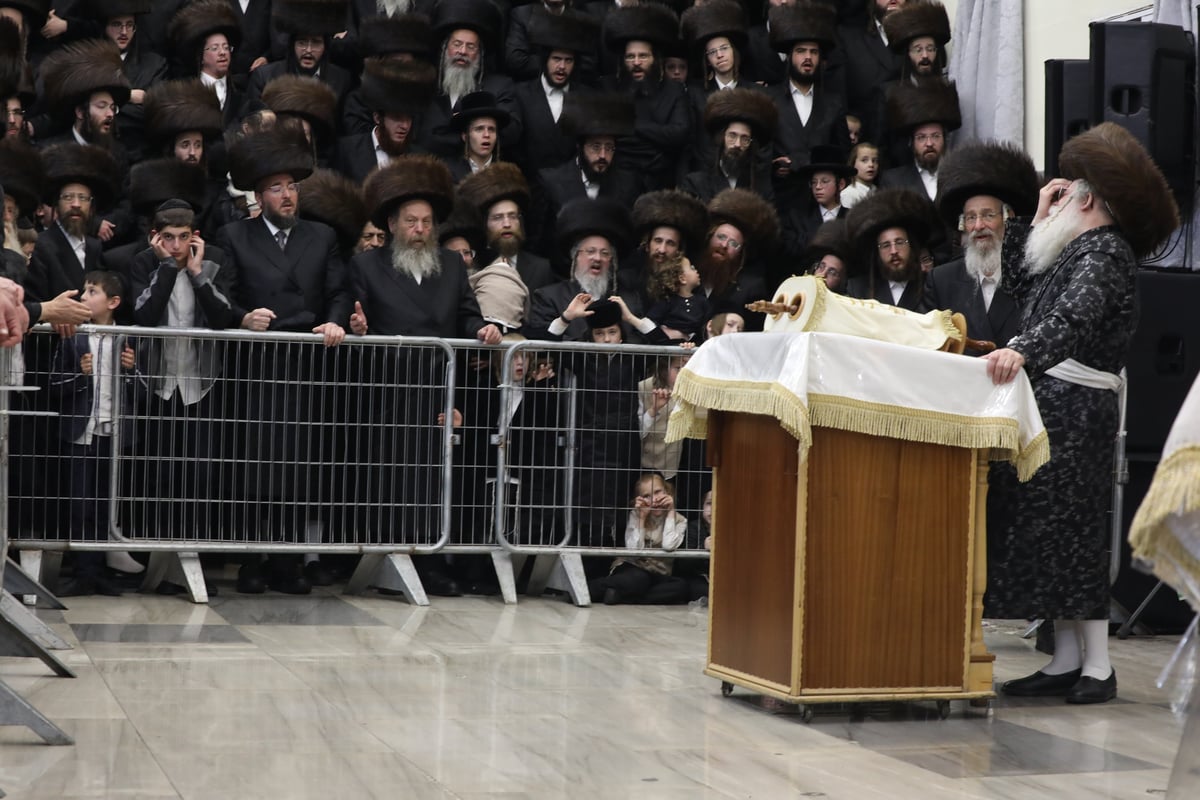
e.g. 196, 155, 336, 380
984, 122, 1180, 703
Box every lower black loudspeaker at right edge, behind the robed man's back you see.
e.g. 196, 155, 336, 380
1126, 270, 1200, 459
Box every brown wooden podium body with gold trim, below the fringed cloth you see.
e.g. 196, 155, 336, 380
704, 410, 992, 704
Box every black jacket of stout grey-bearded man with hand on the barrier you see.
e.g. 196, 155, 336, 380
349, 247, 487, 338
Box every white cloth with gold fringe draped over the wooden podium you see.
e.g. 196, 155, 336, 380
667, 333, 1049, 480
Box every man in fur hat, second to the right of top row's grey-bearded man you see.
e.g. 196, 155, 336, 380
602, 2, 691, 191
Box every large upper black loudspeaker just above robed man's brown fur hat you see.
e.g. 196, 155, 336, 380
1091, 23, 1196, 199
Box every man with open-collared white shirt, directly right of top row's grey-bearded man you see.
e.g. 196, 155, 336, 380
512, 6, 600, 176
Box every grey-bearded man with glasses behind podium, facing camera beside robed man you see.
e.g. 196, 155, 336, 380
918, 142, 1038, 355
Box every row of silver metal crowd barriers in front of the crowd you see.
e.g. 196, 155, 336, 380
4, 326, 708, 603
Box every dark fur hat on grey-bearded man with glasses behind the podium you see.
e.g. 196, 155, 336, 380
937, 142, 1042, 229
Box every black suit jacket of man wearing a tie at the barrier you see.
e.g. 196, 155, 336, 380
216, 217, 353, 332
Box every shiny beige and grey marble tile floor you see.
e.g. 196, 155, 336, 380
0, 587, 1200, 800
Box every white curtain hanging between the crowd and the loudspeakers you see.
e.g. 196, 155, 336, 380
950, 0, 1025, 146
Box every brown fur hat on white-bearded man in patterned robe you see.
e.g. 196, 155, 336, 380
1058, 122, 1180, 258
